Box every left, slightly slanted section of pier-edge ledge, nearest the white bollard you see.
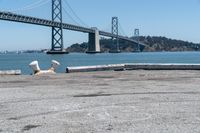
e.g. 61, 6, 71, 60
66, 64, 125, 73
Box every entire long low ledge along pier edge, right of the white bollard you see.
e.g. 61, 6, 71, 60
66, 63, 200, 73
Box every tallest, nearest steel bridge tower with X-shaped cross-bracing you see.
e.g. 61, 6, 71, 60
47, 0, 67, 54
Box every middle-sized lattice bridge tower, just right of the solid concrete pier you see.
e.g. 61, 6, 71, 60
110, 17, 120, 53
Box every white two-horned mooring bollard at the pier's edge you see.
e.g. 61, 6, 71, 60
29, 60, 60, 75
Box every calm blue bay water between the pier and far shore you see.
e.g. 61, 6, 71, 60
0, 52, 200, 74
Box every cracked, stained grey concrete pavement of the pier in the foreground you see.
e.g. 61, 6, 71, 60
0, 70, 200, 133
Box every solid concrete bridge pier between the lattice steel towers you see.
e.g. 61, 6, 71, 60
86, 28, 101, 54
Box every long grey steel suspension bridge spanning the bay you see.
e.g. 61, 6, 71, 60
0, 0, 145, 54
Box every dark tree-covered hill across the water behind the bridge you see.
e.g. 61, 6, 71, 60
66, 36, 200, 52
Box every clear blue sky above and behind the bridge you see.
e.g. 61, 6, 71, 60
0, 0, 200, 50
